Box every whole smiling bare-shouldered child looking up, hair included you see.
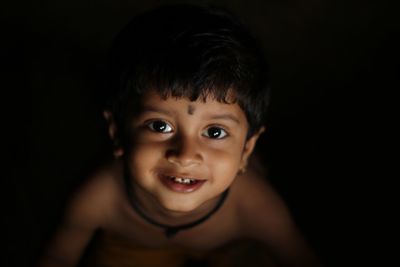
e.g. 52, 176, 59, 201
40, 6, 317, 267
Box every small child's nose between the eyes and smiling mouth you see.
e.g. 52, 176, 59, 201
166, 135, 203, 167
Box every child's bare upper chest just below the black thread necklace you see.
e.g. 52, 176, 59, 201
100, 193, 238, 250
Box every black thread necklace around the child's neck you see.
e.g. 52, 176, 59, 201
124, 165, 229, 238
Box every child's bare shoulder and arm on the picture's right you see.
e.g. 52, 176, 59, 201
241, 177, 321, 267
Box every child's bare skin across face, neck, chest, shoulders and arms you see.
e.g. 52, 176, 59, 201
39, 91, 319, 267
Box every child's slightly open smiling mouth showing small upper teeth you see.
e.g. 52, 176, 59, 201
160, 174, 206, 193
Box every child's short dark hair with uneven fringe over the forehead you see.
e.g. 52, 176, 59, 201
107, 5, 269, 140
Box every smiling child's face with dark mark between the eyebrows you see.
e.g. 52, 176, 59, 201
109, 92, 258, 215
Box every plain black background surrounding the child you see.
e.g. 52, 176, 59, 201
0, 0, 399, 266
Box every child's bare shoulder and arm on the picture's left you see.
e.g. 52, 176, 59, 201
38, 162, 122, 267
